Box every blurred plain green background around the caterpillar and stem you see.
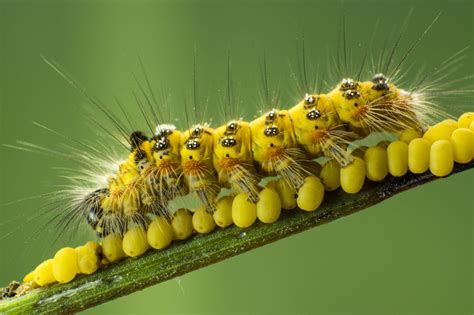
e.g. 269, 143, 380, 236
0, 0, 474, 314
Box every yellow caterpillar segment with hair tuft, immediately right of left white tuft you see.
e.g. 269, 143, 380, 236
180, 125, 219, 213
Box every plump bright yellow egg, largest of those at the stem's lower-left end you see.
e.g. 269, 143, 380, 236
53, 247, 79, 283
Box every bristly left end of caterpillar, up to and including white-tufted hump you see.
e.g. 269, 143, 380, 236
80, 125, 185, 237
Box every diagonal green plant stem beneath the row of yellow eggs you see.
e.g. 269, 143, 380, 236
0, 162, 474, 313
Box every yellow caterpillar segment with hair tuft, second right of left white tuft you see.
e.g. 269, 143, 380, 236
213, 120, 260, 202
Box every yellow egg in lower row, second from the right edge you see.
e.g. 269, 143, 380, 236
430, 140, 454, 177
